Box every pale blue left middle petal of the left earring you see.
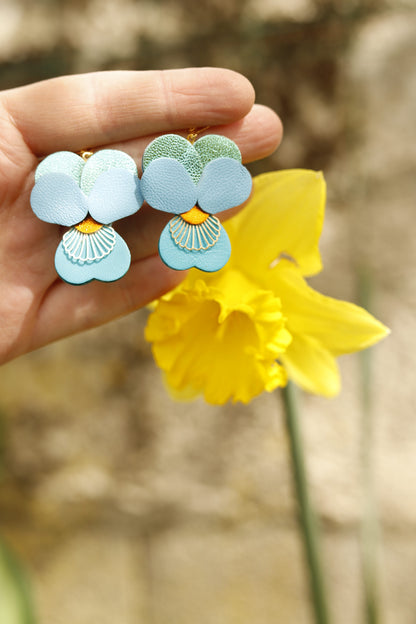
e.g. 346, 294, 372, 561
30, 173, 88, 225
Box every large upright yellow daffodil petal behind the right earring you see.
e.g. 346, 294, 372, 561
226, 169, 326, 277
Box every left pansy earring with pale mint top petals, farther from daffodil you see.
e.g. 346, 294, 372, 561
30, 150, 143, 284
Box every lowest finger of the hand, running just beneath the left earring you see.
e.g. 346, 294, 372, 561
28, 256, 185, 350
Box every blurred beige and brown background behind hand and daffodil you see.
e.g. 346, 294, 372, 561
0, 0, 416, 624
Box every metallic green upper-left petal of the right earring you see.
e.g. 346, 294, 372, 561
142, 134, 203, 184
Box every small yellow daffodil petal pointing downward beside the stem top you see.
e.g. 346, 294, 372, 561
281, 335, 341, 397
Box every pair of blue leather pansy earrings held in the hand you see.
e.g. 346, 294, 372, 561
30, 133, 252, 284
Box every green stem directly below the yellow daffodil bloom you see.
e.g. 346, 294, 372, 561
282, 382, 330, 624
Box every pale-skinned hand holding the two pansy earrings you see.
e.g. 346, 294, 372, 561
0, 68, 282, 363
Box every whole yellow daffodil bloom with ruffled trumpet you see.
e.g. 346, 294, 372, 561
146, 170, 388, 404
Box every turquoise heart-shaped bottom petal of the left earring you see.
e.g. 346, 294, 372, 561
55, 234, 131, 285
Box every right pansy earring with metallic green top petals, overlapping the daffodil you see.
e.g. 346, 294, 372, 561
141, 131, 252, 272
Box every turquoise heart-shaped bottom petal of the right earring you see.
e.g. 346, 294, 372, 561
159, 223, 231, 273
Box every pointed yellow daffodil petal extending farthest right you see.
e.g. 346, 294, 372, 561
268, 261, 389, 356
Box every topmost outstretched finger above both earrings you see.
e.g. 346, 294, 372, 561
1, 68, 254, 156
